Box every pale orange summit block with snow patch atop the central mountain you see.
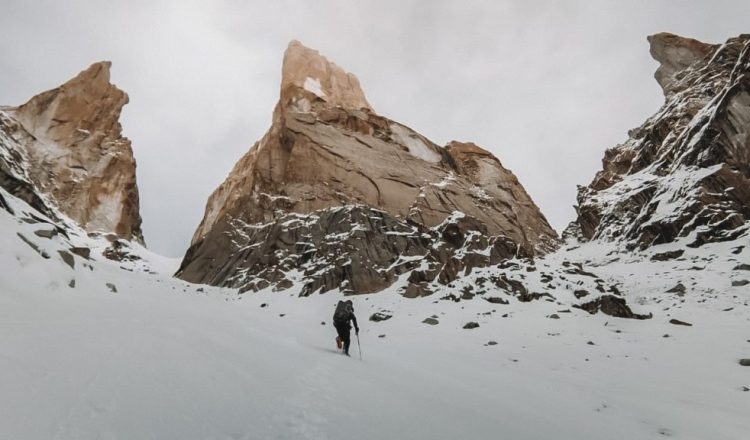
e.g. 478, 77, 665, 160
281, 40, 372, 110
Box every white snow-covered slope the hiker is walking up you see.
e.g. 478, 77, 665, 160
0, 192, 750, 440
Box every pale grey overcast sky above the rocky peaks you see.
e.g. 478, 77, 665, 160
0, 0, 750, 256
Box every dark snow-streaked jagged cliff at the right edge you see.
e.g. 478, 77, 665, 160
569, 34, 750, 249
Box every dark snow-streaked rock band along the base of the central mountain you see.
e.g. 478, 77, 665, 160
181, 205, 530, 296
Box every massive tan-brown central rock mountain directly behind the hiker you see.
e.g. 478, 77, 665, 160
177, 42, 557, 294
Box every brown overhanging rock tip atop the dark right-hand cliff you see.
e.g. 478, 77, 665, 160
647, 32, 719, 94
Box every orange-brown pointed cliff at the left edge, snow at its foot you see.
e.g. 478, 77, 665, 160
0, 62, 143, 242
